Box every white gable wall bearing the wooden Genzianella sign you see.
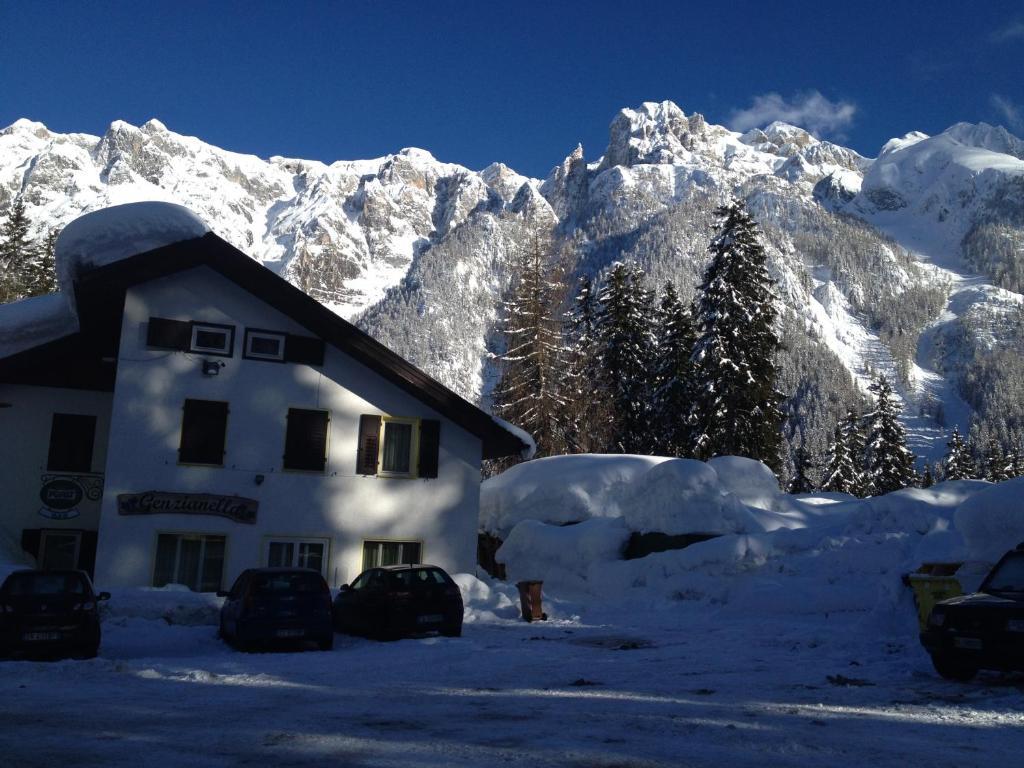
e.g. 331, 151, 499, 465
96, 267, 481, 588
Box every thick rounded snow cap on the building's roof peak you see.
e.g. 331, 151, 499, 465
55, 202, 210, 311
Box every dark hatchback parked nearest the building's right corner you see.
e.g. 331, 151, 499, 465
334, 565, 463, 639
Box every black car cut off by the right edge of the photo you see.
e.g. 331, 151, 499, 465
921, 544, 1024, 680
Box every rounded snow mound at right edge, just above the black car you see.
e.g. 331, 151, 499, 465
955, 477, 1024, 562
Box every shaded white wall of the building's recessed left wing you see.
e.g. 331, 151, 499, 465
0, 384, 113, 554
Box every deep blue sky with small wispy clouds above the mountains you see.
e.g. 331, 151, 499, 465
0, 0, 1024, 175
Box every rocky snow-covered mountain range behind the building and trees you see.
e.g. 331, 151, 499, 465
0, 101, 1024, 468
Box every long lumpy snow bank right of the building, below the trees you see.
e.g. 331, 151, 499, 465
481, 456, 1024, 622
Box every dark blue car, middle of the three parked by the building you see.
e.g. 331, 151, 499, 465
217, 568, 334, 650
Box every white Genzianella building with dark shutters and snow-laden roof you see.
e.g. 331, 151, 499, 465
0, 203, 526, 591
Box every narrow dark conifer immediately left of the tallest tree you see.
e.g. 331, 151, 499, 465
651, 281, 696, 457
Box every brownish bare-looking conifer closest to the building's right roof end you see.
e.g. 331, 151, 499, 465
494, 241, 566, 456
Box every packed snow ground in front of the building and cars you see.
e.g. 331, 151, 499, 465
0, 601, 1024, 768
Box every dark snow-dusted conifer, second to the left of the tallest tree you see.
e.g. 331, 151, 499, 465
596, 262, 654, 454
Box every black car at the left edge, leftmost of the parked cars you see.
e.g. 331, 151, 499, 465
0, 570, 111, 658
